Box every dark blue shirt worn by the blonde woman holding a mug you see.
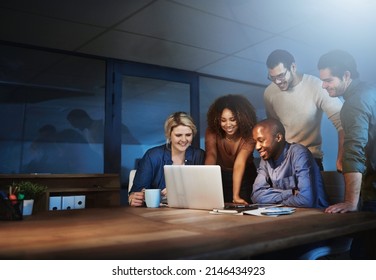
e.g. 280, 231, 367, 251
130, 144, 205, 192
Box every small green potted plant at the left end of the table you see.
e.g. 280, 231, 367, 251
9, 181, 47, 215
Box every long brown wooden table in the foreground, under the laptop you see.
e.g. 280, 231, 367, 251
0, 206, 376, 259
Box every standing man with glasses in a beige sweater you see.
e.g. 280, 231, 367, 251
264, 49, 344, 172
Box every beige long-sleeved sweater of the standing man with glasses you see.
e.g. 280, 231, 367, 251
264, 75, 342, 158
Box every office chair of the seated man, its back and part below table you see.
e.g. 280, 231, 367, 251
299, 171, 352, 260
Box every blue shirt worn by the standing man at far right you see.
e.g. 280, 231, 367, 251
340, 79, 376, 201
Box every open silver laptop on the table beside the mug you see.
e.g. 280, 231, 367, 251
164, 165, 225, 210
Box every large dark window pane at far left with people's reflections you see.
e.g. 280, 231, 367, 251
0, 45, 105, 174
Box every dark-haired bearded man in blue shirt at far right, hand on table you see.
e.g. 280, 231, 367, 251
318, 50, 376, 259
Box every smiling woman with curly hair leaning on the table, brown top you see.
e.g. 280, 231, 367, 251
205, 94, 257, 204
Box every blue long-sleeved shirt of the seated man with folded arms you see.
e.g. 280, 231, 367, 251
252, 143, 328, 208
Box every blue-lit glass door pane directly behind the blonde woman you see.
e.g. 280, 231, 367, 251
121, 76, 190, 179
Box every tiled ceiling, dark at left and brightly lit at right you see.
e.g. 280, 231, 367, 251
0, 0, 376, 85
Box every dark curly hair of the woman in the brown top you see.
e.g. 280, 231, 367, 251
206, 94, 257, 139
